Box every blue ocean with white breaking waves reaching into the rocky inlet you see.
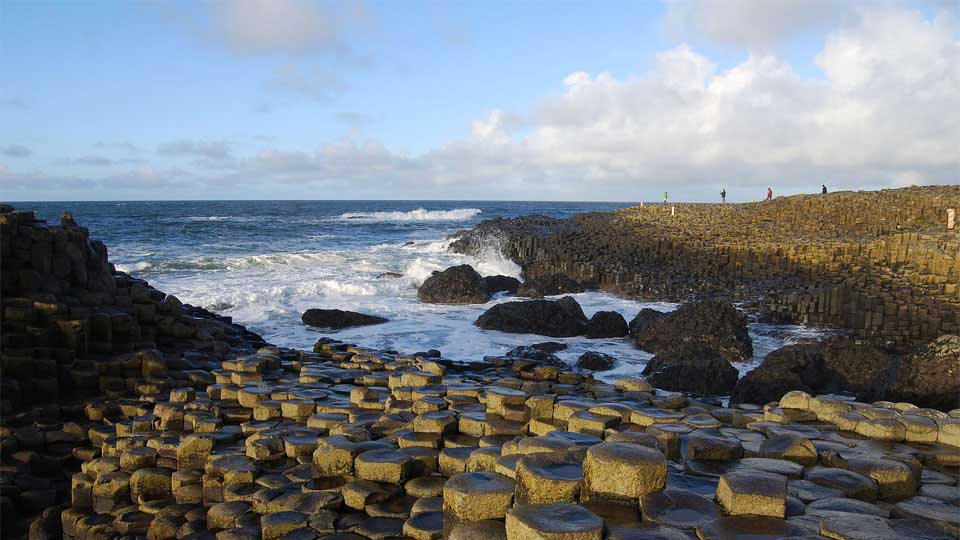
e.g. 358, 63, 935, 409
24, 201, 822, 380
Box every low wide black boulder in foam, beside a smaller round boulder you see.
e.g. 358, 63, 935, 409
474, 296, 587, 337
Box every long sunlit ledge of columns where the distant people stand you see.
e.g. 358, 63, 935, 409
451, 186, 960, 350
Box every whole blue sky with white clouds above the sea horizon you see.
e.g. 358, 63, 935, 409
0, 0, 960, 202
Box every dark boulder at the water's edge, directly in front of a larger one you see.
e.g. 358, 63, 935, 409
643, 343, 740, 396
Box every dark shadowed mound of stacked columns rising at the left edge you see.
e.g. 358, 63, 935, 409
0, 205, 265, 418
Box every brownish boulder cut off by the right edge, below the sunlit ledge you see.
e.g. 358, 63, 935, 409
884, 335, 960, 411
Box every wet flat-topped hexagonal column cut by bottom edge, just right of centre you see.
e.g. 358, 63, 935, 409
506, 503, 603, 540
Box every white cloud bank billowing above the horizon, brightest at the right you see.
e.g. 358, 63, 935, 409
0, 0, 960, 200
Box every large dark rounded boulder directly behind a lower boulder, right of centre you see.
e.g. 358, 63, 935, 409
635, 300, 753, 362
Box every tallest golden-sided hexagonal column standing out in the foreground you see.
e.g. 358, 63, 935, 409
580, 443, 667, 503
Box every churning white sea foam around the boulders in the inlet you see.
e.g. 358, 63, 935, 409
135, 226, 819, 381
